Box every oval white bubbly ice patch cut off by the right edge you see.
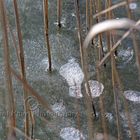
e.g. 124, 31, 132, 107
124, 90, 140, 103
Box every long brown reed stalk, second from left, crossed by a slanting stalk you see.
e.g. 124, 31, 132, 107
13, 0, 30, 137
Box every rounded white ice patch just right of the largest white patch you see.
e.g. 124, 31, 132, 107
85, 80, 104, 98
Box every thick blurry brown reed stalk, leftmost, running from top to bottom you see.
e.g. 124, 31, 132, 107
0, 0, 16, 140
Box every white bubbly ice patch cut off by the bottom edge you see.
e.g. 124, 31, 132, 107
60, 127, 85, 140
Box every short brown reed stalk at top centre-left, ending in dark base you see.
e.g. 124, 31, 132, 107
57, 0, 62, 28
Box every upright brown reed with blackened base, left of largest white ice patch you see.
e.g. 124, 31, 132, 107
43, 0, 52, 72
